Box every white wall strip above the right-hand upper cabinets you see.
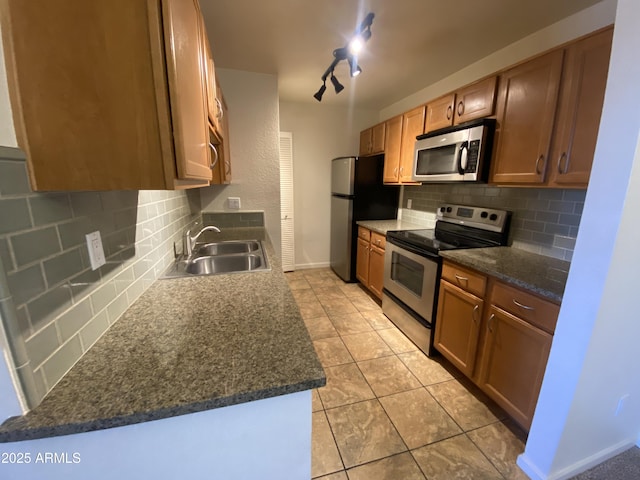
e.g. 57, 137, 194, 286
379, 0, 616, 120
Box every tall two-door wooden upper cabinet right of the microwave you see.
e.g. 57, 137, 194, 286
490, 28, 613, 188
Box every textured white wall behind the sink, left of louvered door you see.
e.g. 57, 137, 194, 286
201, 69, 280, 250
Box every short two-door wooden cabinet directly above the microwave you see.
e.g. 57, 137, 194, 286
424, 76, 498, 133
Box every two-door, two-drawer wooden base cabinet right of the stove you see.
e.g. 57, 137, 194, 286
434, 261, 560, 430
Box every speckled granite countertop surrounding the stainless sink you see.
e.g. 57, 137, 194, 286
0, 228, 326, 442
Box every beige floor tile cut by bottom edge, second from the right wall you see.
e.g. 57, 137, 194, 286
411, 435, 502, 480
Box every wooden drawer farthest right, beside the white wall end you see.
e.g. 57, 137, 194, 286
491, 282, 560, 334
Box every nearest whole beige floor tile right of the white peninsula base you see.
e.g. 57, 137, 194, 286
326, 400, 406, 468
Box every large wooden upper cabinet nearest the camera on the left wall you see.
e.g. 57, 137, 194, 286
0, 0, 211, 190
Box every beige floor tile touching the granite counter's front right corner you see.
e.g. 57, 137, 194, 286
318, 363, 375, 409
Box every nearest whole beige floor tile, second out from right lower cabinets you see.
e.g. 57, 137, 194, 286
378, 388, 462, 449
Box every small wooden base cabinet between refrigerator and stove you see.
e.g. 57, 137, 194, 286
356, 227, 386, 299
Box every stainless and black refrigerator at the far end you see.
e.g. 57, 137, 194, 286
331, 155, 400, 282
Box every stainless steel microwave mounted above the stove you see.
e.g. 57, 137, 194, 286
412, 118, 495, 183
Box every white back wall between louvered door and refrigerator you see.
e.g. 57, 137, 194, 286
280, 101, 378, 268
